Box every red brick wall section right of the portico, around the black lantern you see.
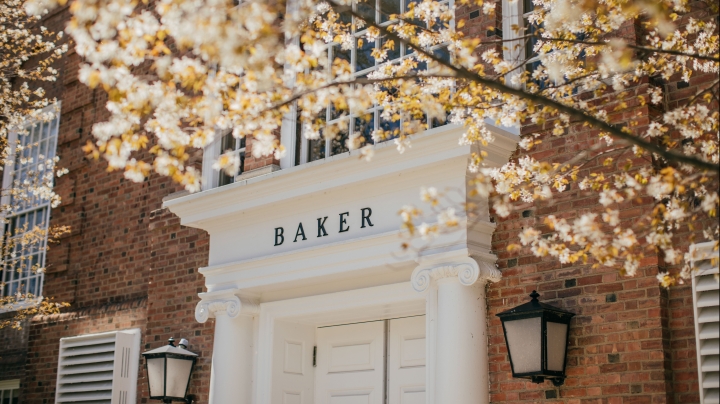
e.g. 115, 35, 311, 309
480, 4, 717, 403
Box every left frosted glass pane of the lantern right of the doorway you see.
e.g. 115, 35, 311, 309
504, 317, 542, 373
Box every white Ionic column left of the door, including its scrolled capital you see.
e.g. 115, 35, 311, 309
195, 295, 258, 404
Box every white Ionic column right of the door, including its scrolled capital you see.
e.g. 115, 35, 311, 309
412, 258, 501, 404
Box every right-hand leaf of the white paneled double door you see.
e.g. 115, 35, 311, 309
386, 316, 427, 404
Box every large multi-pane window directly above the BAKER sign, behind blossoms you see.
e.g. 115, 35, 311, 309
295, 0, 450, 164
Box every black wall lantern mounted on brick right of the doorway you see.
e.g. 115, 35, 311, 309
497, 290, 575, 386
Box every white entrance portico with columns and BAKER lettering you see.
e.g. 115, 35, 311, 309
165, 126, 515, 404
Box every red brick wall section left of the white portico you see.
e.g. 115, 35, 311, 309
9, 4, 219, 403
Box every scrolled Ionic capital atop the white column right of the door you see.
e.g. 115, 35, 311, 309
410, 257, 502, 292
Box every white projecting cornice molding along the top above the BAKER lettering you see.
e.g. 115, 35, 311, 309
163, 125, 517, 230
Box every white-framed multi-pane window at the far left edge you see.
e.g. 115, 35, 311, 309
0, 114, 59, 296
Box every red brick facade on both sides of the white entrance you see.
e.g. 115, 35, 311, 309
7, 4, 708, 403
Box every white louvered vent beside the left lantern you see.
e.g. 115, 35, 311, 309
55, 329, 140, 404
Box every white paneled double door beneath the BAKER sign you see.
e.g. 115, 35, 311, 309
314, 316, 426, 404
